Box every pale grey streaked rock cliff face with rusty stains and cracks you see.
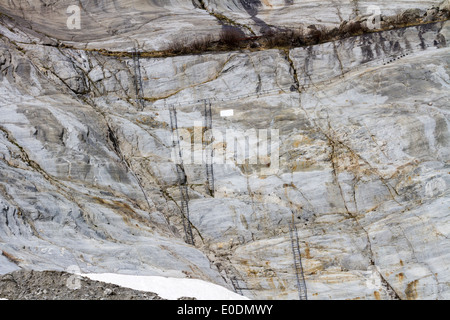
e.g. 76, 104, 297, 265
0, 0, 450, 299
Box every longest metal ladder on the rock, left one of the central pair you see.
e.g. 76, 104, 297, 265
169, 105, 195, 246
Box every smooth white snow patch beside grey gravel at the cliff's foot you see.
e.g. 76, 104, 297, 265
81, 273, 249, 300
